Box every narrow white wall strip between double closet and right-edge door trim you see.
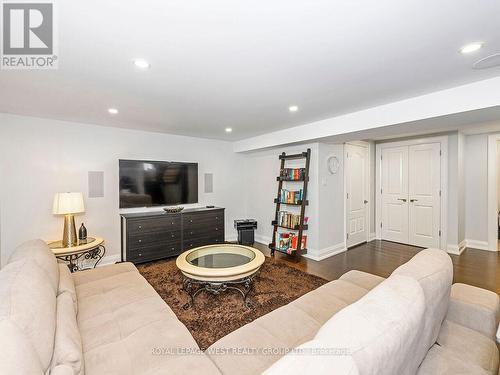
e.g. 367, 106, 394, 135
464, 134, 488, 246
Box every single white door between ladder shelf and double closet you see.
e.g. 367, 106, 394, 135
345, 145, 369, 247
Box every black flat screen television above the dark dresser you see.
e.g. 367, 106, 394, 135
120, 160, 198, 208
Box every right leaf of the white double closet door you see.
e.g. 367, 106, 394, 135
408, 143, 441, 248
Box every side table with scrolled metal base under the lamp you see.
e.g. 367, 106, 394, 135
47, 236, 106, 272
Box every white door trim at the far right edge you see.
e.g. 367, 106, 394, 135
488, 133, 500, 251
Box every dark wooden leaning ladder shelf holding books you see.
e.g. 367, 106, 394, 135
269, 148, 311, 257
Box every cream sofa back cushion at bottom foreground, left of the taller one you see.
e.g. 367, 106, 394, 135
315, 275, 425, 375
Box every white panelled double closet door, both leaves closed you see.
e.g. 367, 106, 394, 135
380, 143, 441, 248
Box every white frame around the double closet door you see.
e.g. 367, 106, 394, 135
375, 136, 448, 251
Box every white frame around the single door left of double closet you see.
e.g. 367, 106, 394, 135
343, 141, 374, 249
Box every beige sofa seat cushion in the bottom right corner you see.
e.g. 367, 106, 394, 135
437, 320, 498, 374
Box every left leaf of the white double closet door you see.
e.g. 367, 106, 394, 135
381, 146, 409, 243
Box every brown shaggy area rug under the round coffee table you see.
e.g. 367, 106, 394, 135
138, 257, 327, 350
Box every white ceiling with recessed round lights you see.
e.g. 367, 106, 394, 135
0, 0, 500, 140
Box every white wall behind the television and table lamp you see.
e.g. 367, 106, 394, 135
0, 114, 246, 264
